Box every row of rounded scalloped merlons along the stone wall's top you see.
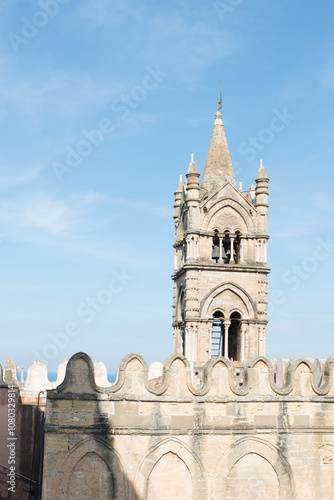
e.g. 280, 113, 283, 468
0, 353, 334, 402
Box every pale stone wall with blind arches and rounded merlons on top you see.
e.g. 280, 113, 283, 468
43, 353, 334, 500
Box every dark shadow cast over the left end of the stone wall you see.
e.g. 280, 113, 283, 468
47, 353, 140, 500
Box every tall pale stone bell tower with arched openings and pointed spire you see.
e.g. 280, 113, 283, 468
172, 107, 270, 366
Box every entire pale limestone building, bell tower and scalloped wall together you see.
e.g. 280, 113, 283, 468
0, 107, 334, 500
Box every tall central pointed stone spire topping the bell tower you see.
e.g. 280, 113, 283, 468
201, 111, 236, 191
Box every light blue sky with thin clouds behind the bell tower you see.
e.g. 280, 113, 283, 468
0, 0, 334, 372
